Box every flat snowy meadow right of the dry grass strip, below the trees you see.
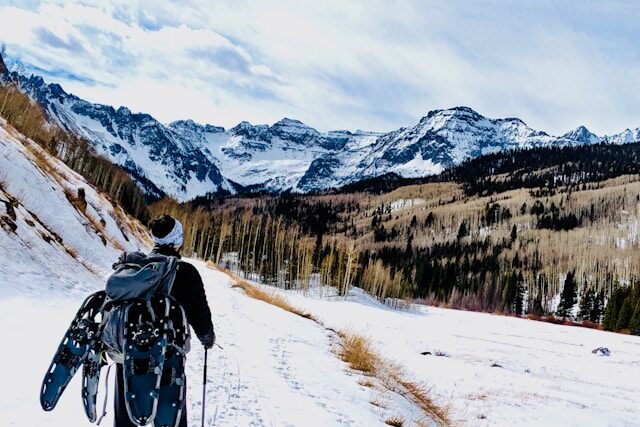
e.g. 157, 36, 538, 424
282, 291, 640, 426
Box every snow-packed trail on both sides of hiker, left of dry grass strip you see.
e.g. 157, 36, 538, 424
0, 260, 395, 427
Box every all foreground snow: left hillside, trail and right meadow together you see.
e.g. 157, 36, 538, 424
0, 116, 640, 427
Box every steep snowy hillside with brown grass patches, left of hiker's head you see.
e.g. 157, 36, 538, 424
0, 119, 145, 296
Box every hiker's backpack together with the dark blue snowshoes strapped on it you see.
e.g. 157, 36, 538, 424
40, 252, 189, 426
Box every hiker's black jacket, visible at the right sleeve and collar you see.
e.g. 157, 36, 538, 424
151, 246, 213, 337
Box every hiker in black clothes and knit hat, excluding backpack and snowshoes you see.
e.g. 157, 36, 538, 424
114, 215, 216, 427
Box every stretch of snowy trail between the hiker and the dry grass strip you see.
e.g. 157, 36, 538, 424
188, 261, 392, 426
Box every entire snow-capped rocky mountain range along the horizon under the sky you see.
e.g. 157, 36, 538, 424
5, 65, 640, 200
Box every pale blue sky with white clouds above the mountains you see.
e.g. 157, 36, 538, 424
0, 0, 640, 134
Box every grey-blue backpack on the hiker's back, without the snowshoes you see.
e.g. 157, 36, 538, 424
101, 252, 178, 363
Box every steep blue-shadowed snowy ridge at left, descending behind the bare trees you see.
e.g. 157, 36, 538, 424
14, 76, 233, 199
